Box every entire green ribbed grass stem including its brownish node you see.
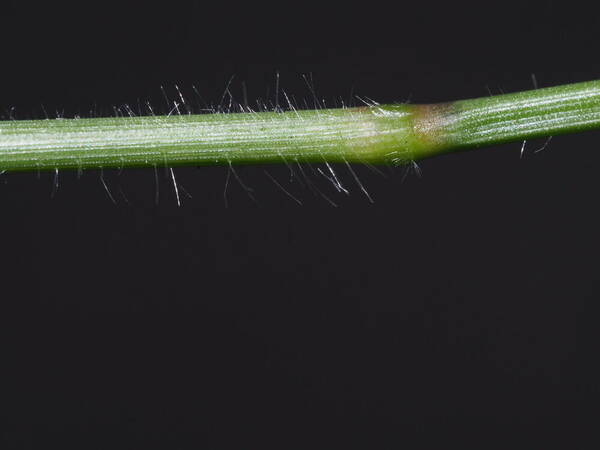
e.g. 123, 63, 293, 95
0, 80, 600, 171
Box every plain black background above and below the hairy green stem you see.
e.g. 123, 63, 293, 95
0, 0, 600, 449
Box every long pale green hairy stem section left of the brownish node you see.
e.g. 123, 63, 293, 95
0, 107, 418, 170
